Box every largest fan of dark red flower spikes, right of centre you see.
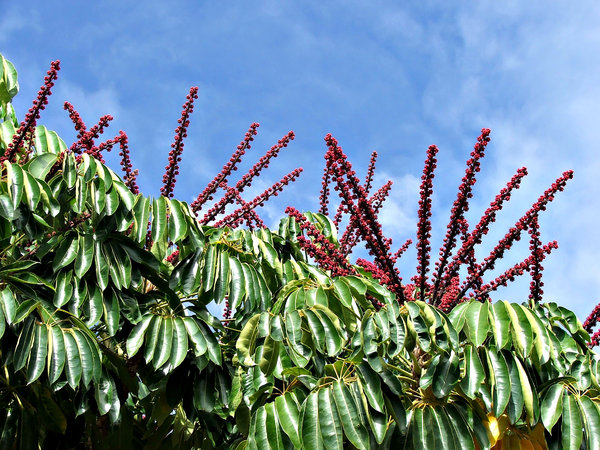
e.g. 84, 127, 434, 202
288, 128, 576, 312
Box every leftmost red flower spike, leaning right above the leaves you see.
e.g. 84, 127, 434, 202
0, 60, 60, 163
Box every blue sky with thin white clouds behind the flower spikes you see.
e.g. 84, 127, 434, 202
0, 0, 600, 319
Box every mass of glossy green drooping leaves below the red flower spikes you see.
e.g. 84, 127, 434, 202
0, 51, 600, 449
